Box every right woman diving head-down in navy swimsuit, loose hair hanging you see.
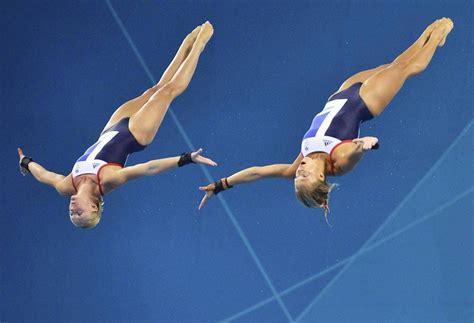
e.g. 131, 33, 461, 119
199, 18, 454, 222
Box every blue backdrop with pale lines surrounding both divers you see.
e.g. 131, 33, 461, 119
0, 0, 474, 322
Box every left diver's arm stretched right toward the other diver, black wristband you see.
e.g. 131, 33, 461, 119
109, 149, 217, 187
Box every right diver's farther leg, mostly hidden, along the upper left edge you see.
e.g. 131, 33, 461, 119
338, 20, 439, 92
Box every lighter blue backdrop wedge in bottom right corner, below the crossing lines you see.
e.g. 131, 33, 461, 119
303, 193, 474, 322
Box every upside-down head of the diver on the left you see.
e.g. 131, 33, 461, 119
69, 193, 104, 229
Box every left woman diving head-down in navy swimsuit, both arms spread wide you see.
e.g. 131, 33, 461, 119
18, 22, 216, 228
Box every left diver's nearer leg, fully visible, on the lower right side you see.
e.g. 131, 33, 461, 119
129, 22, 214, 145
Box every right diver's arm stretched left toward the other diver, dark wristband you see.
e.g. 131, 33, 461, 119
199, 154, 303, 209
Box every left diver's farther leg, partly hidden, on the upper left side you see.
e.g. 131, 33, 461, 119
104, 26, 201, 130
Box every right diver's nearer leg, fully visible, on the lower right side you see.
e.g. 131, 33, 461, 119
360, 18, 453, 116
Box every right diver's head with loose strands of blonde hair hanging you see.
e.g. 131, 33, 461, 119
295, 155, 336, 221
